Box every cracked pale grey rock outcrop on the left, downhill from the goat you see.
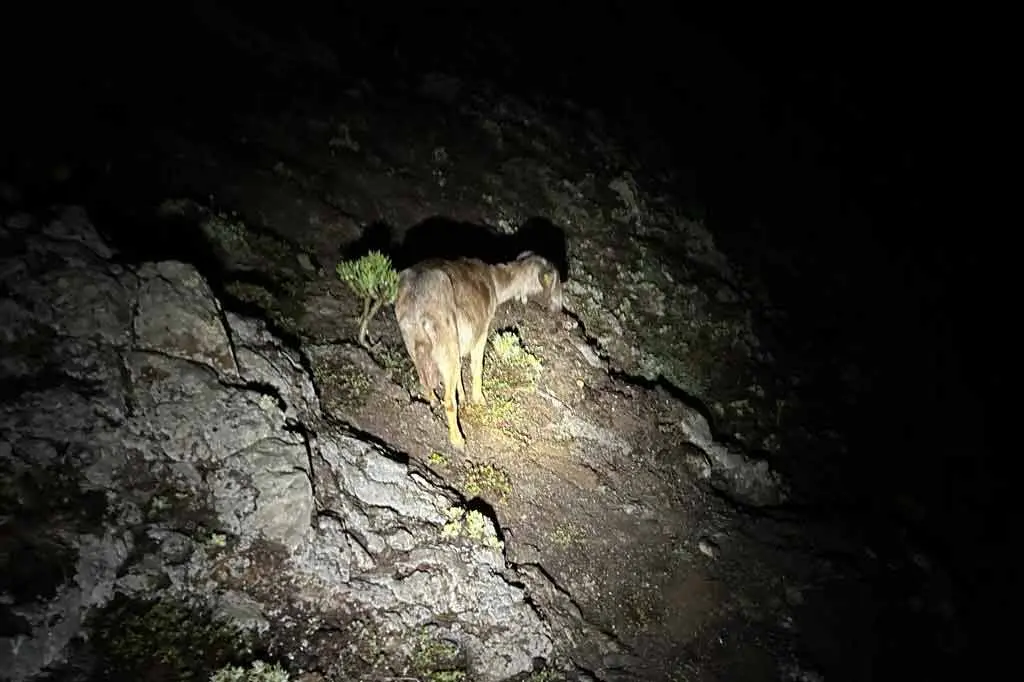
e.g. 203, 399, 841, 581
0, 209, 552, 681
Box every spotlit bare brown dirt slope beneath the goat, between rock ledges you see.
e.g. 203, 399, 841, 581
296, 274, 798, 679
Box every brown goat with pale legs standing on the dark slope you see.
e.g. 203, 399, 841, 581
394, 251, 562, 451
